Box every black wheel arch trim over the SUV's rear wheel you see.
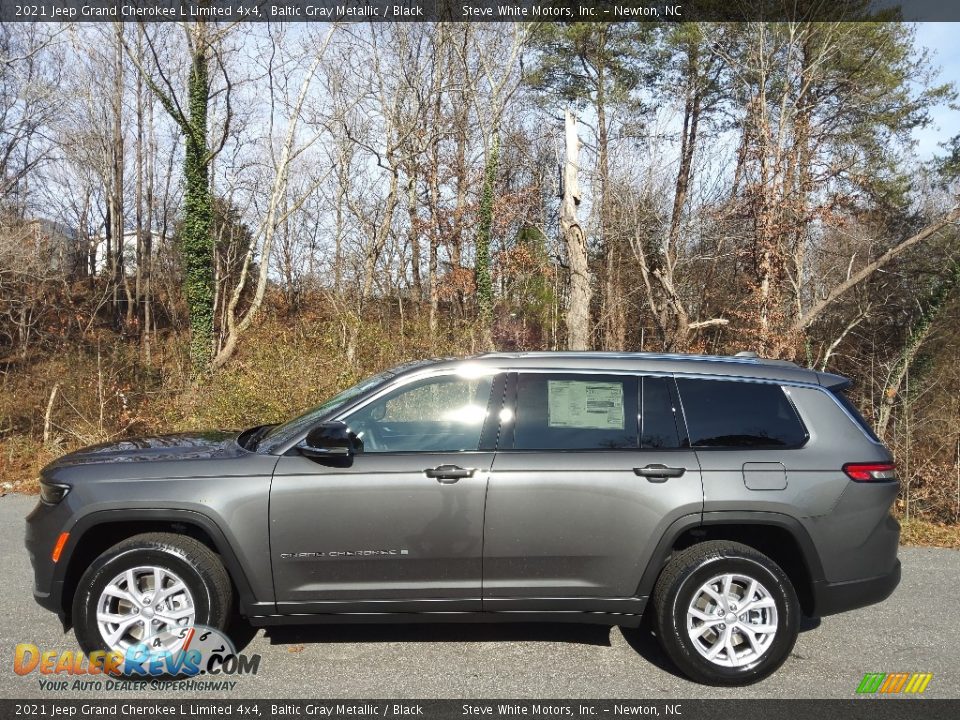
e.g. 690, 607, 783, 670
637, 511, 823, 616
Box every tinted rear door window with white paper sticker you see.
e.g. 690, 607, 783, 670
513, 374, 638, 450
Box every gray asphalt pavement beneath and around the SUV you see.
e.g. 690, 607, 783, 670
0, 495, 960, 699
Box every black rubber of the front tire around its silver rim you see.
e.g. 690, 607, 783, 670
73, 546, 214, 653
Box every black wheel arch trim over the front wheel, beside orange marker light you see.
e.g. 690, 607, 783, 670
55, 509, 256, 627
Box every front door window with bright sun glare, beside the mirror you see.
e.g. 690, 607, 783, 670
344, 375, 492, 453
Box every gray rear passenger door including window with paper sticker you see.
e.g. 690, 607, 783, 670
483, 372, 703, 612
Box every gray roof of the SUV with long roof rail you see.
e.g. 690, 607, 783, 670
419, 351, 849, 387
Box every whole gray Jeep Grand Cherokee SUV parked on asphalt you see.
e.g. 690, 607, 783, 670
27, 353, 900, 684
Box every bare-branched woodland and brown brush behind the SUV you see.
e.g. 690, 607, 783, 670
0, 22, 960, 546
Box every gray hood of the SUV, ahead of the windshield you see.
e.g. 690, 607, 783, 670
45, 430, 242, 470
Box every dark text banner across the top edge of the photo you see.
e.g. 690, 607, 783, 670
0, 0, 960, 22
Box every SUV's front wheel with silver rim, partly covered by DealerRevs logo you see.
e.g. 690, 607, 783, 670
73, 533, 233, 654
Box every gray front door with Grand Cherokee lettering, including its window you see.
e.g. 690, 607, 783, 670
270, 374, 502, 613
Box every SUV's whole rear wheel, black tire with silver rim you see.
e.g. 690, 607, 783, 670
653, 540, 800, 685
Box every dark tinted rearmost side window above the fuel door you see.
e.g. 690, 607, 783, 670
677, 378, 807, 448
